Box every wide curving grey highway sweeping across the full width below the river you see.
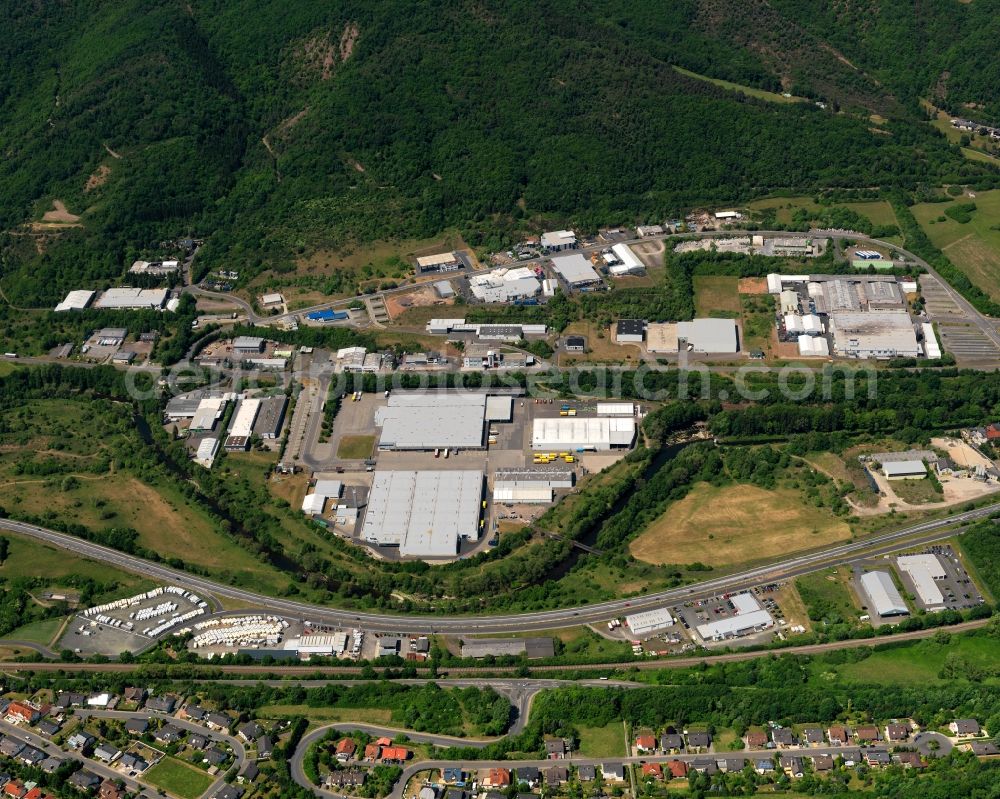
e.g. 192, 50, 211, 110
0, 503, 1000, 635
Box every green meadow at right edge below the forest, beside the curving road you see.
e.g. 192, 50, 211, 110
911, 189, 1000, 300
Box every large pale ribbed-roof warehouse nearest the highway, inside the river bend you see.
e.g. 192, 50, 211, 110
361, 470, 483, 558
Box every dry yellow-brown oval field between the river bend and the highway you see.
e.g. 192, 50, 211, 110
629, 483, 851, 567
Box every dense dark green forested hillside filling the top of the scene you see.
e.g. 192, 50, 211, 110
0, 0, 1000, 306
